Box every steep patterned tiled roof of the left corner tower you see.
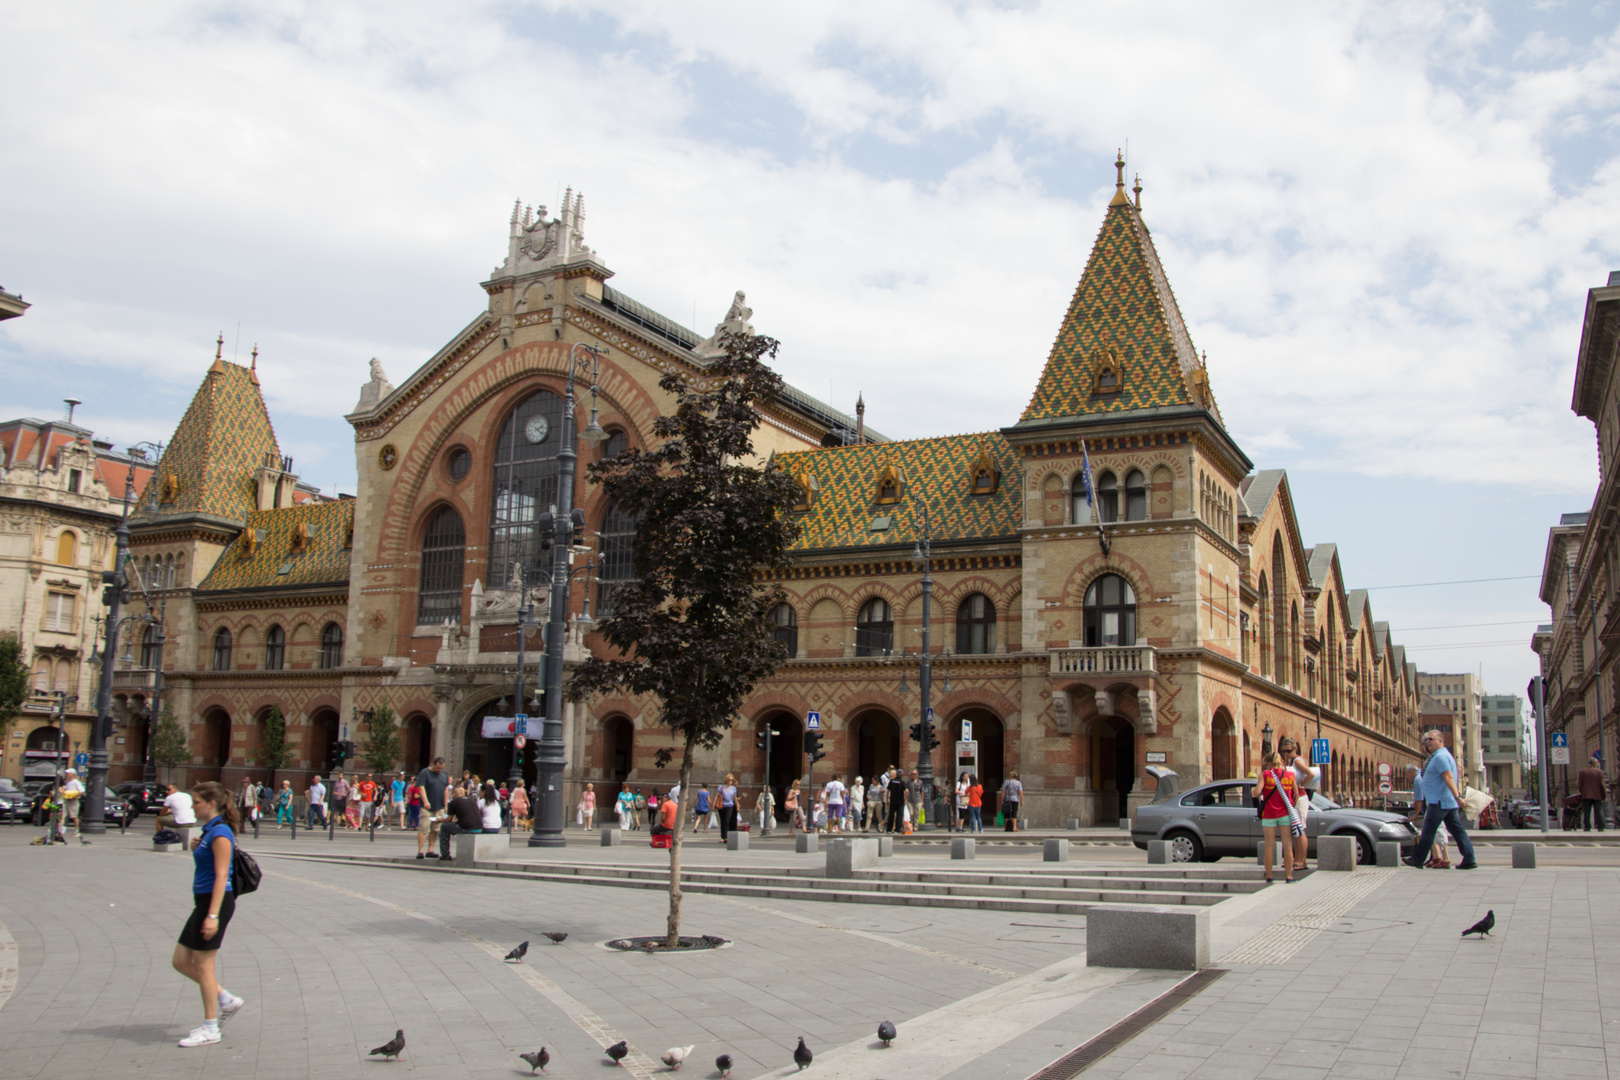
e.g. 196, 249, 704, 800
139, 359, 280, 521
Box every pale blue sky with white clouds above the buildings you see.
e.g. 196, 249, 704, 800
0, 0, 1620, 712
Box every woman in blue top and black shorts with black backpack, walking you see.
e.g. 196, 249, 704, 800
173, 780, 241, 1046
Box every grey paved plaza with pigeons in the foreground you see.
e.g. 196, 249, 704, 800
0, 827, 1620, 1080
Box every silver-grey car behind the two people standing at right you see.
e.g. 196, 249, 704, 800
1131, 769, 1418, 863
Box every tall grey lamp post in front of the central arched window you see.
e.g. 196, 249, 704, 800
528, 342, 608, 847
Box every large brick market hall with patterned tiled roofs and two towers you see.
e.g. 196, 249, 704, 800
101, 170, 1419, 824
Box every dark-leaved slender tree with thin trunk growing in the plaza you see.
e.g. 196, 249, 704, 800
569, 334, 799, 947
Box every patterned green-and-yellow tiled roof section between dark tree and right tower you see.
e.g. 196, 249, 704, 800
776, 432, 1022, 551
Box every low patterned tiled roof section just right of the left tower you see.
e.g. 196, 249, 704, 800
198, 499, 355, 593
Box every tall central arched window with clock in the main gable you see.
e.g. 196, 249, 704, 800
486, 390, 562, 573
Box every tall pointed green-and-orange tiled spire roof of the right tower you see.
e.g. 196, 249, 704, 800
1022, 157, 1221, 423
